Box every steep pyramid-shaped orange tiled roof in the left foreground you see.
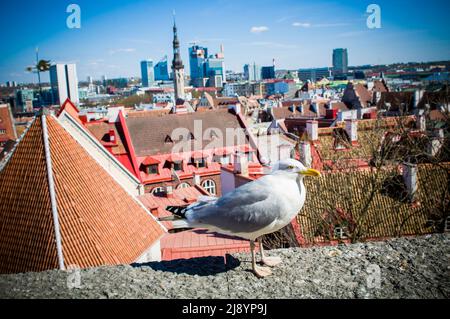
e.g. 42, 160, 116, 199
0, 116, 164, 273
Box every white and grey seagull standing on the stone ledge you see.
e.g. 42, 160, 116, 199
160, 159, 321, 278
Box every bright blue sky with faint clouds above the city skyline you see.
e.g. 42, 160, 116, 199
0, 0, 450, 82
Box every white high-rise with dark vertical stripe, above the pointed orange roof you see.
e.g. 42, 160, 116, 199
50, 64, 79, 105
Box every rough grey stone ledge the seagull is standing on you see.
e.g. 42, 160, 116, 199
0, 234, 450, 299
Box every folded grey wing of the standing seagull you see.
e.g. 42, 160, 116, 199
186, 182, 281, 233
